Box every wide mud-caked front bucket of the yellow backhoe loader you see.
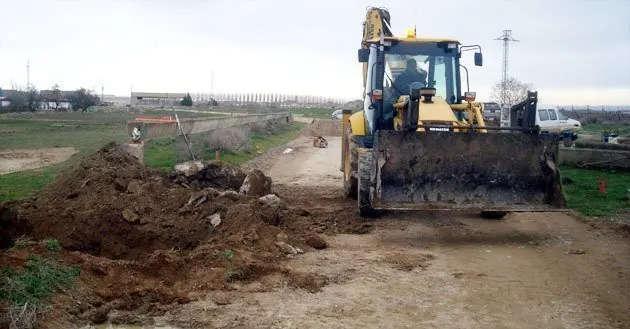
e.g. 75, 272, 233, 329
370, 131, 566, 212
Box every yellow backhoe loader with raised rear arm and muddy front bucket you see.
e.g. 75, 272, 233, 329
341, 8, 566, 218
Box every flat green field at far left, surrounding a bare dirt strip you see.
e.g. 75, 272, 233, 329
0, 110, 225, 202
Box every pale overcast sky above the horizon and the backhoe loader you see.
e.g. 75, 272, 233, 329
0, 0, 630, 105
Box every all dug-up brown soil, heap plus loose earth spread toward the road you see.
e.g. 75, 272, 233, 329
0, 143, 371, 324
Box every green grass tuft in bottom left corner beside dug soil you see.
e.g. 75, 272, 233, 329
0, 240, 80, 306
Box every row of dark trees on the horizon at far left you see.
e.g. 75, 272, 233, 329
0, 85, 101, 112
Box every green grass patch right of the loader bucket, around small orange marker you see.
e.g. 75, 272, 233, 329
560, 168, 630, 216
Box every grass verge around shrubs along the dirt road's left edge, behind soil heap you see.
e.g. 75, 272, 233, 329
144, 122, 304, 170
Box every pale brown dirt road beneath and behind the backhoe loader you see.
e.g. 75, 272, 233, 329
156, 138, 630, 328
